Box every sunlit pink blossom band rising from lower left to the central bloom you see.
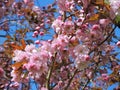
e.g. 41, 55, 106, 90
11, 35, 68, 82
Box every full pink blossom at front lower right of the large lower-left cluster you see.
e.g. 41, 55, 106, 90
24, 54, 48, 75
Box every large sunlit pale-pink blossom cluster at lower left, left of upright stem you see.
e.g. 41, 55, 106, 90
11, 43, 50, 82
